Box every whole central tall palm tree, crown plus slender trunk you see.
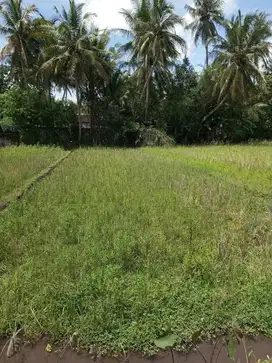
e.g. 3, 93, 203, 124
121, 0, 186, 120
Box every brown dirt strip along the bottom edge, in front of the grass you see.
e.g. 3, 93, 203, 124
0, 337, 272, 363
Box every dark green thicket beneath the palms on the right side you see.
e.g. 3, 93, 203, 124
159, 64, 272, 144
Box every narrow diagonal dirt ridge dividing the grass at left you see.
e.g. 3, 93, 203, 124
0, 151, 72, 212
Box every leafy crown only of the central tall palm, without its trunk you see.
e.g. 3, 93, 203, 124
121, 0, 186, 66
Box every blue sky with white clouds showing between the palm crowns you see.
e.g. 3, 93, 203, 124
0, 0, 272, 68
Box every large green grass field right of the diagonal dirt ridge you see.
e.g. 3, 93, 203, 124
0, 145, 272, 352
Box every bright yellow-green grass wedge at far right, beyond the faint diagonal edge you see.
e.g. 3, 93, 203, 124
144, 143, 272, 194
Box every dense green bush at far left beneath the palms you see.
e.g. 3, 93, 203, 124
0, 88, 76, 146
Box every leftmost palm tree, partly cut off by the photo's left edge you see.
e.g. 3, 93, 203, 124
0, 0, 38, 88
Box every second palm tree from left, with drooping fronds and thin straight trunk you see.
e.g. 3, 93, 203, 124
41, 0, 107, 142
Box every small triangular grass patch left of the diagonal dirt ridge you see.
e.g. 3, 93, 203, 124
0, 146, 67, 201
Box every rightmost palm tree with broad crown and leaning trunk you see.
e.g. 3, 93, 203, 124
205, 11, 272, 119
